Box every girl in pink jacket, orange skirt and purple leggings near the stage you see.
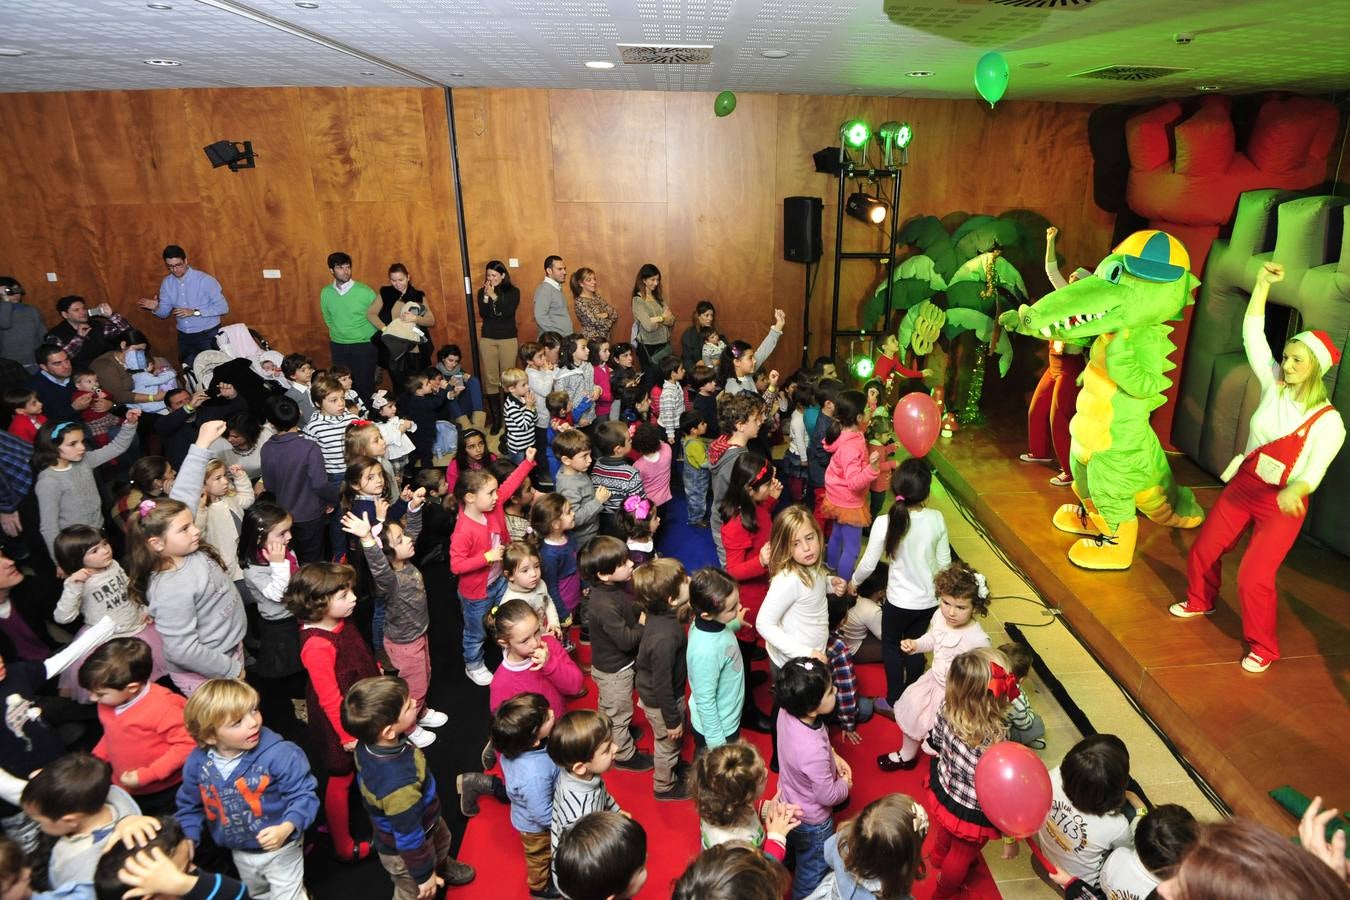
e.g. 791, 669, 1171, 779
821, 390, 882, 582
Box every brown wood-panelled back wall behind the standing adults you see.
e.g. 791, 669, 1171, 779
0, 88, 1111, 383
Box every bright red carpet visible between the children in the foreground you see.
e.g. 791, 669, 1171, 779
459, 646, 1000, 900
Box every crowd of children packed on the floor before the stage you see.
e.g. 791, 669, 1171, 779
0, 304, 1339, 900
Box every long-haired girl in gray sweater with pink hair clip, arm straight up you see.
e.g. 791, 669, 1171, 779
127, 420, 246, 696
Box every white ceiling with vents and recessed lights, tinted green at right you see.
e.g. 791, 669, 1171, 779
0, 0, 1350, 103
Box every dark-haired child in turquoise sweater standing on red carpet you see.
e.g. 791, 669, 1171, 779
684, 567, 745, 750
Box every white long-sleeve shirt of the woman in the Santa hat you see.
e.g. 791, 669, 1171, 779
1242, 316, 1346, 490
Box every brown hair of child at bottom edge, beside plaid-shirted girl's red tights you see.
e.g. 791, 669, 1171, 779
838, 793, 929, 900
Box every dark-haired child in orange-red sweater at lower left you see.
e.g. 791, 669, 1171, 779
80, 637, 197, 815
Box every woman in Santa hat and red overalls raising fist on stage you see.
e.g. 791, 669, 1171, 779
1169, 263, 1346, 672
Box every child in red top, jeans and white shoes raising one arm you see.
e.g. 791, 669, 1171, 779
450, 447, 535, 687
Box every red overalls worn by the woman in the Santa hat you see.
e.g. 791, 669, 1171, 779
1187, 403, 1332, 661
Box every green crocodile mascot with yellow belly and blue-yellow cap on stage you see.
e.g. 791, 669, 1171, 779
1000, 231, 1204, 569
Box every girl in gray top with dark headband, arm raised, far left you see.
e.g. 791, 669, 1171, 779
32, 409, 140, 557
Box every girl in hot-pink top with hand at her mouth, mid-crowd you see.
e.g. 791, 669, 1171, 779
485, 599, 582, 719
